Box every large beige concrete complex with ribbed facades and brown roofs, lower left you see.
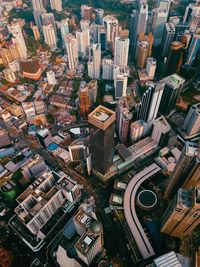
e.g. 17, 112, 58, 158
15, 171, 81, 234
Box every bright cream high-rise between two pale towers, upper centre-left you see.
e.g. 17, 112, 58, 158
76, 28, 90, 58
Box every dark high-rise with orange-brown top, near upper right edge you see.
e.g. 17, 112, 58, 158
165, 41, 183, 76
